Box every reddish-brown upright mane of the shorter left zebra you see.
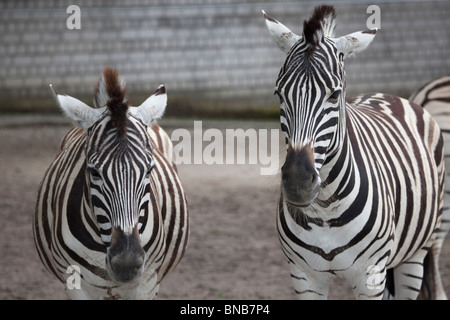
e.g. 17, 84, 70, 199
94, 68, 128, 138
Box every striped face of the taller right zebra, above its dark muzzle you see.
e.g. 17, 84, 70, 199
275, 39, 345, 154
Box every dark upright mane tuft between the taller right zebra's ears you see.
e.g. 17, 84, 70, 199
303, 5, 336, 47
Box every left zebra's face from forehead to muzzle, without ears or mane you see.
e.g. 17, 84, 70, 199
86, 116, 154, 283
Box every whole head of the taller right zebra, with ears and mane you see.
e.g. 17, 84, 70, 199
263, 5, 376, 207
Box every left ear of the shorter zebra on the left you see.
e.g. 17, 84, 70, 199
50, 85, 105, 131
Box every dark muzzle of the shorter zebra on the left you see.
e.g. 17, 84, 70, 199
106, 227, 145, 283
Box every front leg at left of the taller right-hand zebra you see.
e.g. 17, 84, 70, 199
290, 263, 329, 300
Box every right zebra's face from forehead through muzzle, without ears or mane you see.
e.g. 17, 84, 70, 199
275, 38, 345, 206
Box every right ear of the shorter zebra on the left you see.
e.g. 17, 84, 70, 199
130, 85, 167, 126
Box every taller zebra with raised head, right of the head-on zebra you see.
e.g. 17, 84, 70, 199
263, 5, 446, 299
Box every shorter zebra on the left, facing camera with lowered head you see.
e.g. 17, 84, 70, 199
33, 68, 189, 299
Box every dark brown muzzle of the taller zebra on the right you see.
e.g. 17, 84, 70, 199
281, 146, 321, 207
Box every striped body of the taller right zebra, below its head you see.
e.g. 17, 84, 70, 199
277, 94, 443, 298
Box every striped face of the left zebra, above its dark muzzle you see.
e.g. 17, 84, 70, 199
86, 116, 154, 240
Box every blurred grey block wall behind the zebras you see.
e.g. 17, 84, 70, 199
0, 0, 450, 112
